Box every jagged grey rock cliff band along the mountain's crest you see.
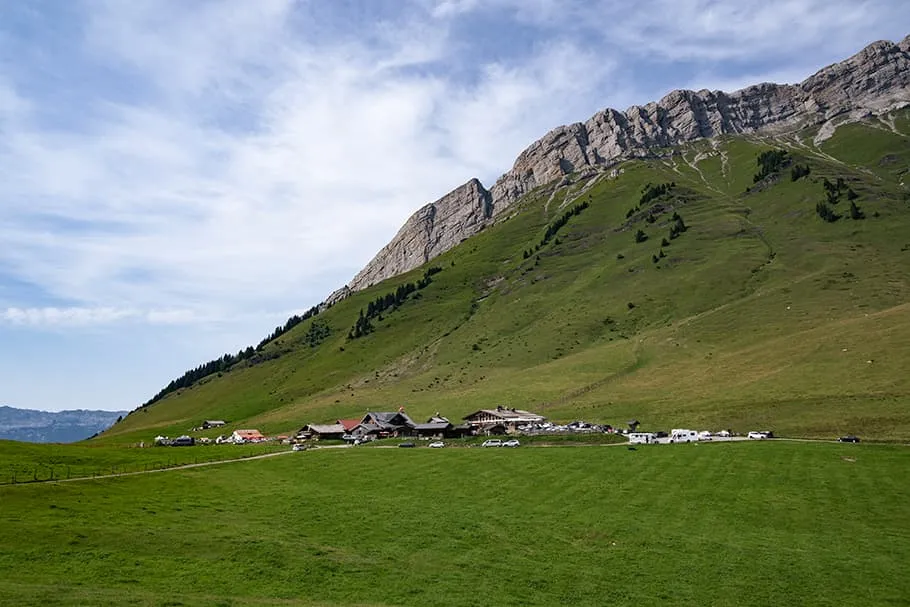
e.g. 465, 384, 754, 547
344, 36, 910, 294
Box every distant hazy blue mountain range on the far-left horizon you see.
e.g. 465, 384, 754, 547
0, 406, 127, 443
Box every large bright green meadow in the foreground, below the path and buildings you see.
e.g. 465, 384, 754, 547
0, 441, 910, 605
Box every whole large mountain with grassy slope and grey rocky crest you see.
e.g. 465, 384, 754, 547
97, 40, 910, 443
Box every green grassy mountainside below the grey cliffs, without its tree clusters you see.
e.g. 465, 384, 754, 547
101, 113, 910, 442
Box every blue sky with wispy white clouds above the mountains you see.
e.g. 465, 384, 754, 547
0, 0, 910, 411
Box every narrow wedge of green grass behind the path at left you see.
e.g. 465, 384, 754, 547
0, 441, 289, 484
